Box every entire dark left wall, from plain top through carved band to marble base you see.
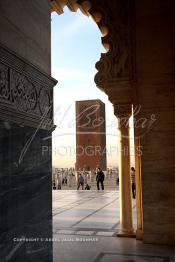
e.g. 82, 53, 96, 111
0, 0, 56, 262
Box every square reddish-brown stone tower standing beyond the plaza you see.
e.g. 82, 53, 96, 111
76, 100, 106, 170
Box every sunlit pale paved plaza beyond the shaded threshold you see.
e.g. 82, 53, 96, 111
53, 190, 135, 236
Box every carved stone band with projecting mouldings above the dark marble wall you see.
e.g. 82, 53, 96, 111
0, 46, 57, 129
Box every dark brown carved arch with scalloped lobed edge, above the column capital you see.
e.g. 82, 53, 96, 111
51, 0, 135, 94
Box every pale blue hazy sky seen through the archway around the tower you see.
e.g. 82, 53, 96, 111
52, 8, 130, 167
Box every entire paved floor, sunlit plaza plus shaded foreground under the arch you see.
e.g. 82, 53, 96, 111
53, 190, 175, 262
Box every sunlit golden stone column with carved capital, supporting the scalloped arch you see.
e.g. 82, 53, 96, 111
114, 104, 135, 237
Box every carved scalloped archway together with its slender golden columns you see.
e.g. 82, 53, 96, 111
51, 0, 143, 238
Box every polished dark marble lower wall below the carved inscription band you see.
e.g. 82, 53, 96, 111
0, 121, 52, 262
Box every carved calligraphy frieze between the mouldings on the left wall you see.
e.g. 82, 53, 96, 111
0, 64, 51, 117
